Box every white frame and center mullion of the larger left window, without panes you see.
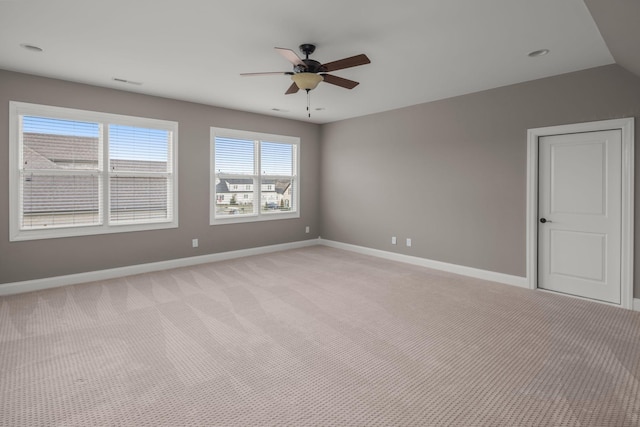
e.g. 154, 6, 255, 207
9, 101, 178, 241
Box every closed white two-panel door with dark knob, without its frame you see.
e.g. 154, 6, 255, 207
538, 130, 622, 304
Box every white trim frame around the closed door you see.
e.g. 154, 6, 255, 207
526, 117, 634, 310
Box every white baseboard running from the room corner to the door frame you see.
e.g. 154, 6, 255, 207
319, 238, 529, 289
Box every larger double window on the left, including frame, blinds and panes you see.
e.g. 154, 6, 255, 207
10, 101, 178, 240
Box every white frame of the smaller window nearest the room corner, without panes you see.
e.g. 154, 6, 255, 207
209, 127, 300, 225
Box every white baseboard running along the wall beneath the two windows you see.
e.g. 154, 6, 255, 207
0, 239, 318, 296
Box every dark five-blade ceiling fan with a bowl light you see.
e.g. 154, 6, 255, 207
240, 43, 371, 95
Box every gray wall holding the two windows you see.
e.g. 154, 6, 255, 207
0, 70, 320, 284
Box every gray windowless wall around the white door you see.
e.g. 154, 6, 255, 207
320, 65, 640, 298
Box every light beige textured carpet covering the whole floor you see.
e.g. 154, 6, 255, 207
0, 246, 640, 427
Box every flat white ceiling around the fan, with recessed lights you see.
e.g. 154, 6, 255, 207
0, 0, 614, 123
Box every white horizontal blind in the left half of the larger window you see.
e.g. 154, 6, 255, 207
19, 116, 102, 229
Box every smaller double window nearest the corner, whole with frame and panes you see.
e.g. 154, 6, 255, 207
210, 128, 300, 224
